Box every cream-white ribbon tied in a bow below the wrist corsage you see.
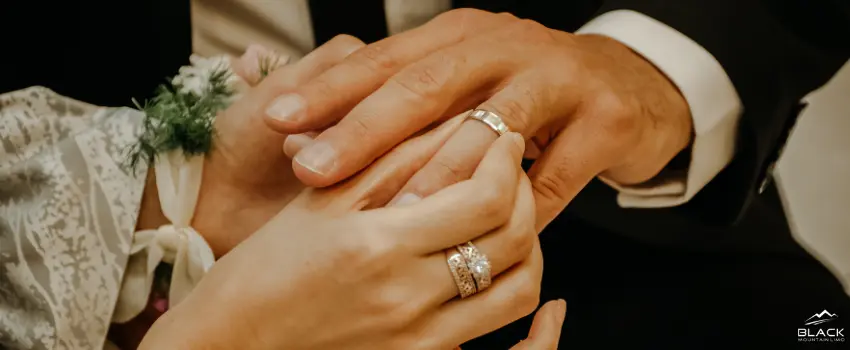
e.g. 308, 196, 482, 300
112, 150, 215, 323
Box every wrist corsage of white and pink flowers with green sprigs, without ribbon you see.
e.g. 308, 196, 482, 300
127, 46, 288, 169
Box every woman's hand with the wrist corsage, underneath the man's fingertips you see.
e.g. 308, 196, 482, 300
188, 36, 364, 256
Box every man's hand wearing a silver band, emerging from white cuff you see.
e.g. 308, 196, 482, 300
266, 10, 691, 229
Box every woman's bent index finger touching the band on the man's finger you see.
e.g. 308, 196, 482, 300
372, 133, 525, 254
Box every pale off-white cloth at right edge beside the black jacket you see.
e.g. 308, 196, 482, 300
775, 62, 850, 294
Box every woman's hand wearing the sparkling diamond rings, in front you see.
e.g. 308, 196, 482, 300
137, 126, 542, 349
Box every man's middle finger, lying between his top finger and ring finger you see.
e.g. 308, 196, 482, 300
293, 32, 521, 187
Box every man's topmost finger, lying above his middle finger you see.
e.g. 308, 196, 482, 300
266, 9, 516, 134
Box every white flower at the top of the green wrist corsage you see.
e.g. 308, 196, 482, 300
171, 55, 246, 96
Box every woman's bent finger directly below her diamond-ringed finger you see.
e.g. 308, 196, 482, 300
415, 237, 543, 349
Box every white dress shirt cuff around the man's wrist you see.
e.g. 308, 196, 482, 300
576, 10, 742, 208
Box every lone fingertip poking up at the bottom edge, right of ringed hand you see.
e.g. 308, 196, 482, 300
511, 299, 567, 350
